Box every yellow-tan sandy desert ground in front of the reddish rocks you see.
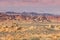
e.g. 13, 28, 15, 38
0, 20, 60, 40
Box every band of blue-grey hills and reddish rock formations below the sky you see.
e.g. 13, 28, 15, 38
0, 12, 60, 22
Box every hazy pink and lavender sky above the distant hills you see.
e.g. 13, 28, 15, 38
0, 0, 60, 14
